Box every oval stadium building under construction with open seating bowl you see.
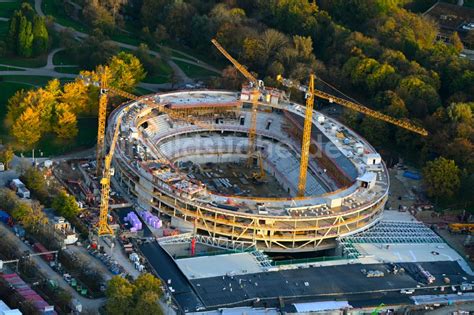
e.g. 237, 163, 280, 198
107, 88, 389, 252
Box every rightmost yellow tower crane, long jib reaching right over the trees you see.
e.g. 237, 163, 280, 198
277, 74, 428, 197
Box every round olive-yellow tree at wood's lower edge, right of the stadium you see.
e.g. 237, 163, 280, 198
423, 157, 461, 199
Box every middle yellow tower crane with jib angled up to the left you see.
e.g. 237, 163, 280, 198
211, 39, 264, 166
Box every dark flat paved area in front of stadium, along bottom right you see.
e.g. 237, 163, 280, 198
191, 262, 474, 307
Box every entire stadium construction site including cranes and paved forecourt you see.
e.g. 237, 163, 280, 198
1, 41, 474, 314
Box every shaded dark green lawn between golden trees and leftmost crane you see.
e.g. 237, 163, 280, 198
35, 117, 97, 156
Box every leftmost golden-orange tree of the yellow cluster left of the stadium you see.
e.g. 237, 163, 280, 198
11, 107, 41, 149
